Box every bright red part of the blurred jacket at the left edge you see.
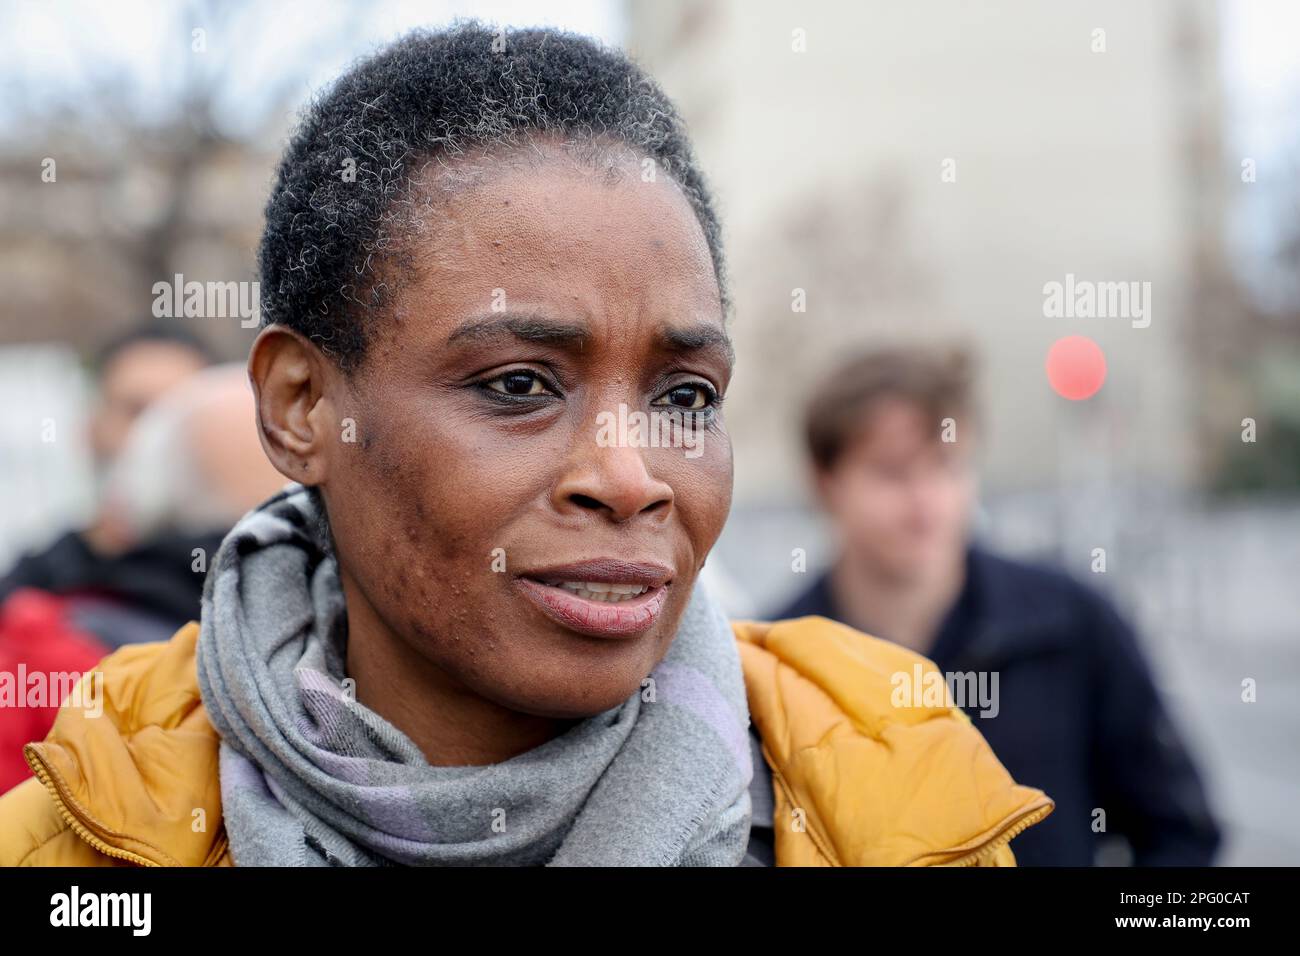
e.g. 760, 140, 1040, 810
0, 588, 108, 793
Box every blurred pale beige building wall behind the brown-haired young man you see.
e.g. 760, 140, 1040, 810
628, 0, 1230, 502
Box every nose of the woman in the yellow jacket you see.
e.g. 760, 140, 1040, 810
555, 445, 672, 522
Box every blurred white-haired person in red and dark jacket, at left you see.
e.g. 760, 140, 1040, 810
0, 365, 283, 792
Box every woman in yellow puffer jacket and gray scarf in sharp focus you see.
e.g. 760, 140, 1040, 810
0, 25, 1050, 865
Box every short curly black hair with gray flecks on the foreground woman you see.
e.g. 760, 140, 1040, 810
259, 21, 728, 371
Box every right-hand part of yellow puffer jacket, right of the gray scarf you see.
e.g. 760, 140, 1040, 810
733, 617, 1053, 866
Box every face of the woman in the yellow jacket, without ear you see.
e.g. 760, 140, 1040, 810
321, 149, 732, 717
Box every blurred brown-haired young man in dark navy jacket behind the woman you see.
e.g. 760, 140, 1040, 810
774, 349, 1219, 866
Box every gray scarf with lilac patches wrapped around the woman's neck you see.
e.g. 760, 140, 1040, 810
198, 485, 751, 866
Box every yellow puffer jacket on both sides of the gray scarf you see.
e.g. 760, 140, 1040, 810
0, 618, 1052, 866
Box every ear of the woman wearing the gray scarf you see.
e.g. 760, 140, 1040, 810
248, 325, 339, 485
